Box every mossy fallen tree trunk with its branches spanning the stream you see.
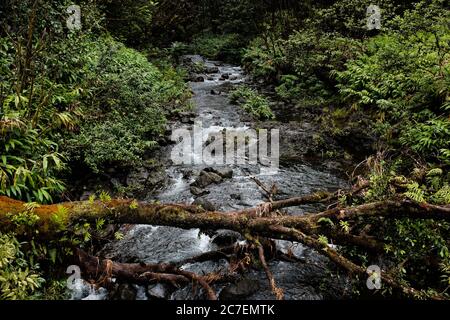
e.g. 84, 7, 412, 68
0, 194, 450, 298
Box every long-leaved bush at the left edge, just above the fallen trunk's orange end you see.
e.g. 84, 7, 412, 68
0, 3, 87, 202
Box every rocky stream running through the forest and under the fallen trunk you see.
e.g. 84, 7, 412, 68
72, 56, 349, 300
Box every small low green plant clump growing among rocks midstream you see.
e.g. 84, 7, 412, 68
230, 86, 275, 120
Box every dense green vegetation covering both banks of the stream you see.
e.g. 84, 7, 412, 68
0, 0, 450, 299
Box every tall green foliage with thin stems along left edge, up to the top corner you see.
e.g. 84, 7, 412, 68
0, 0, 107, 202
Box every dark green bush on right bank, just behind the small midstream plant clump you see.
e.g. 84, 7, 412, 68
243, 29, 358, 104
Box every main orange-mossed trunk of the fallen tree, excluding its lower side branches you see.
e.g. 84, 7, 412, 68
0, 197, 450, 240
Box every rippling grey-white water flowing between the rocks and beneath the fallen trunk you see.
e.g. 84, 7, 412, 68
71, 56, 352, 299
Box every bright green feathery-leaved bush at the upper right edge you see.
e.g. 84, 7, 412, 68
335, 6, 450, 162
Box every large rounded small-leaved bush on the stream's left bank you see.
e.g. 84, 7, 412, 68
66, 39, 189, 172
